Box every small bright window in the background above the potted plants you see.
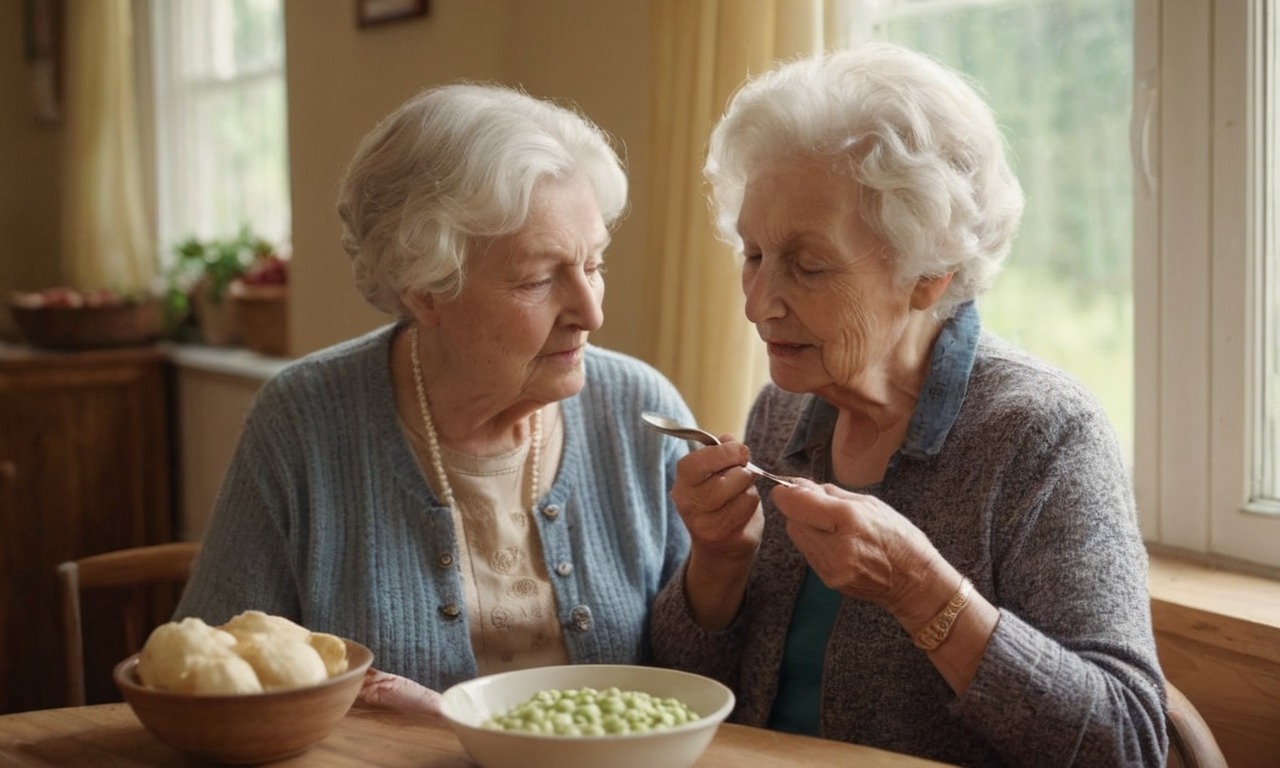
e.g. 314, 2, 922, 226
151, 0, 291, 256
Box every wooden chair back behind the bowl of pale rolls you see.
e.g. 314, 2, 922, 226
58, 541, 200, 707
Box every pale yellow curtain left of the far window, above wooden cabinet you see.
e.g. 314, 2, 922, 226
61, 0, 156, 291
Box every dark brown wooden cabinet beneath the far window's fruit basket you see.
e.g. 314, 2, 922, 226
0, 346, 175, 714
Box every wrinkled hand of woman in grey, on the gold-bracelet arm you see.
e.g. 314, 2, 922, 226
773, 479, 942, 614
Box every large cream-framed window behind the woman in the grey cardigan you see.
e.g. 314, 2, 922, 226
845, 0, 1280, 567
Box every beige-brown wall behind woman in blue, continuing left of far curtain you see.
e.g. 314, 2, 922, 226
0, 0, 649, 356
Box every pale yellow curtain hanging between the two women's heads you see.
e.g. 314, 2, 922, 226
646, 0, 838, 435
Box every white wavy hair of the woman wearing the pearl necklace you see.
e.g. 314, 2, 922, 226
338, 83, 627, 317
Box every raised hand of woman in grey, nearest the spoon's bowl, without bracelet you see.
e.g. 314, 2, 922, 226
671, 435, 764, 559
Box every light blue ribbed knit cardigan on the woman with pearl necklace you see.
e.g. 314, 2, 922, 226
174, 325, 691, 690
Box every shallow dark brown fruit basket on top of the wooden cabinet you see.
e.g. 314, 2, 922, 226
9, 300, 164, 349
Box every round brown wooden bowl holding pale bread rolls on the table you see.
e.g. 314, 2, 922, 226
113, 640, 374, 764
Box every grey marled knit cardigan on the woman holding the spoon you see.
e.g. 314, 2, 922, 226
653, 333, 1166, 768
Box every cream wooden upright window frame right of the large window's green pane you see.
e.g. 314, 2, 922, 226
1132, 0, 1280, 568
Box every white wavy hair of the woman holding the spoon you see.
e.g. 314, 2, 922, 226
703, 42, 1023, 319
